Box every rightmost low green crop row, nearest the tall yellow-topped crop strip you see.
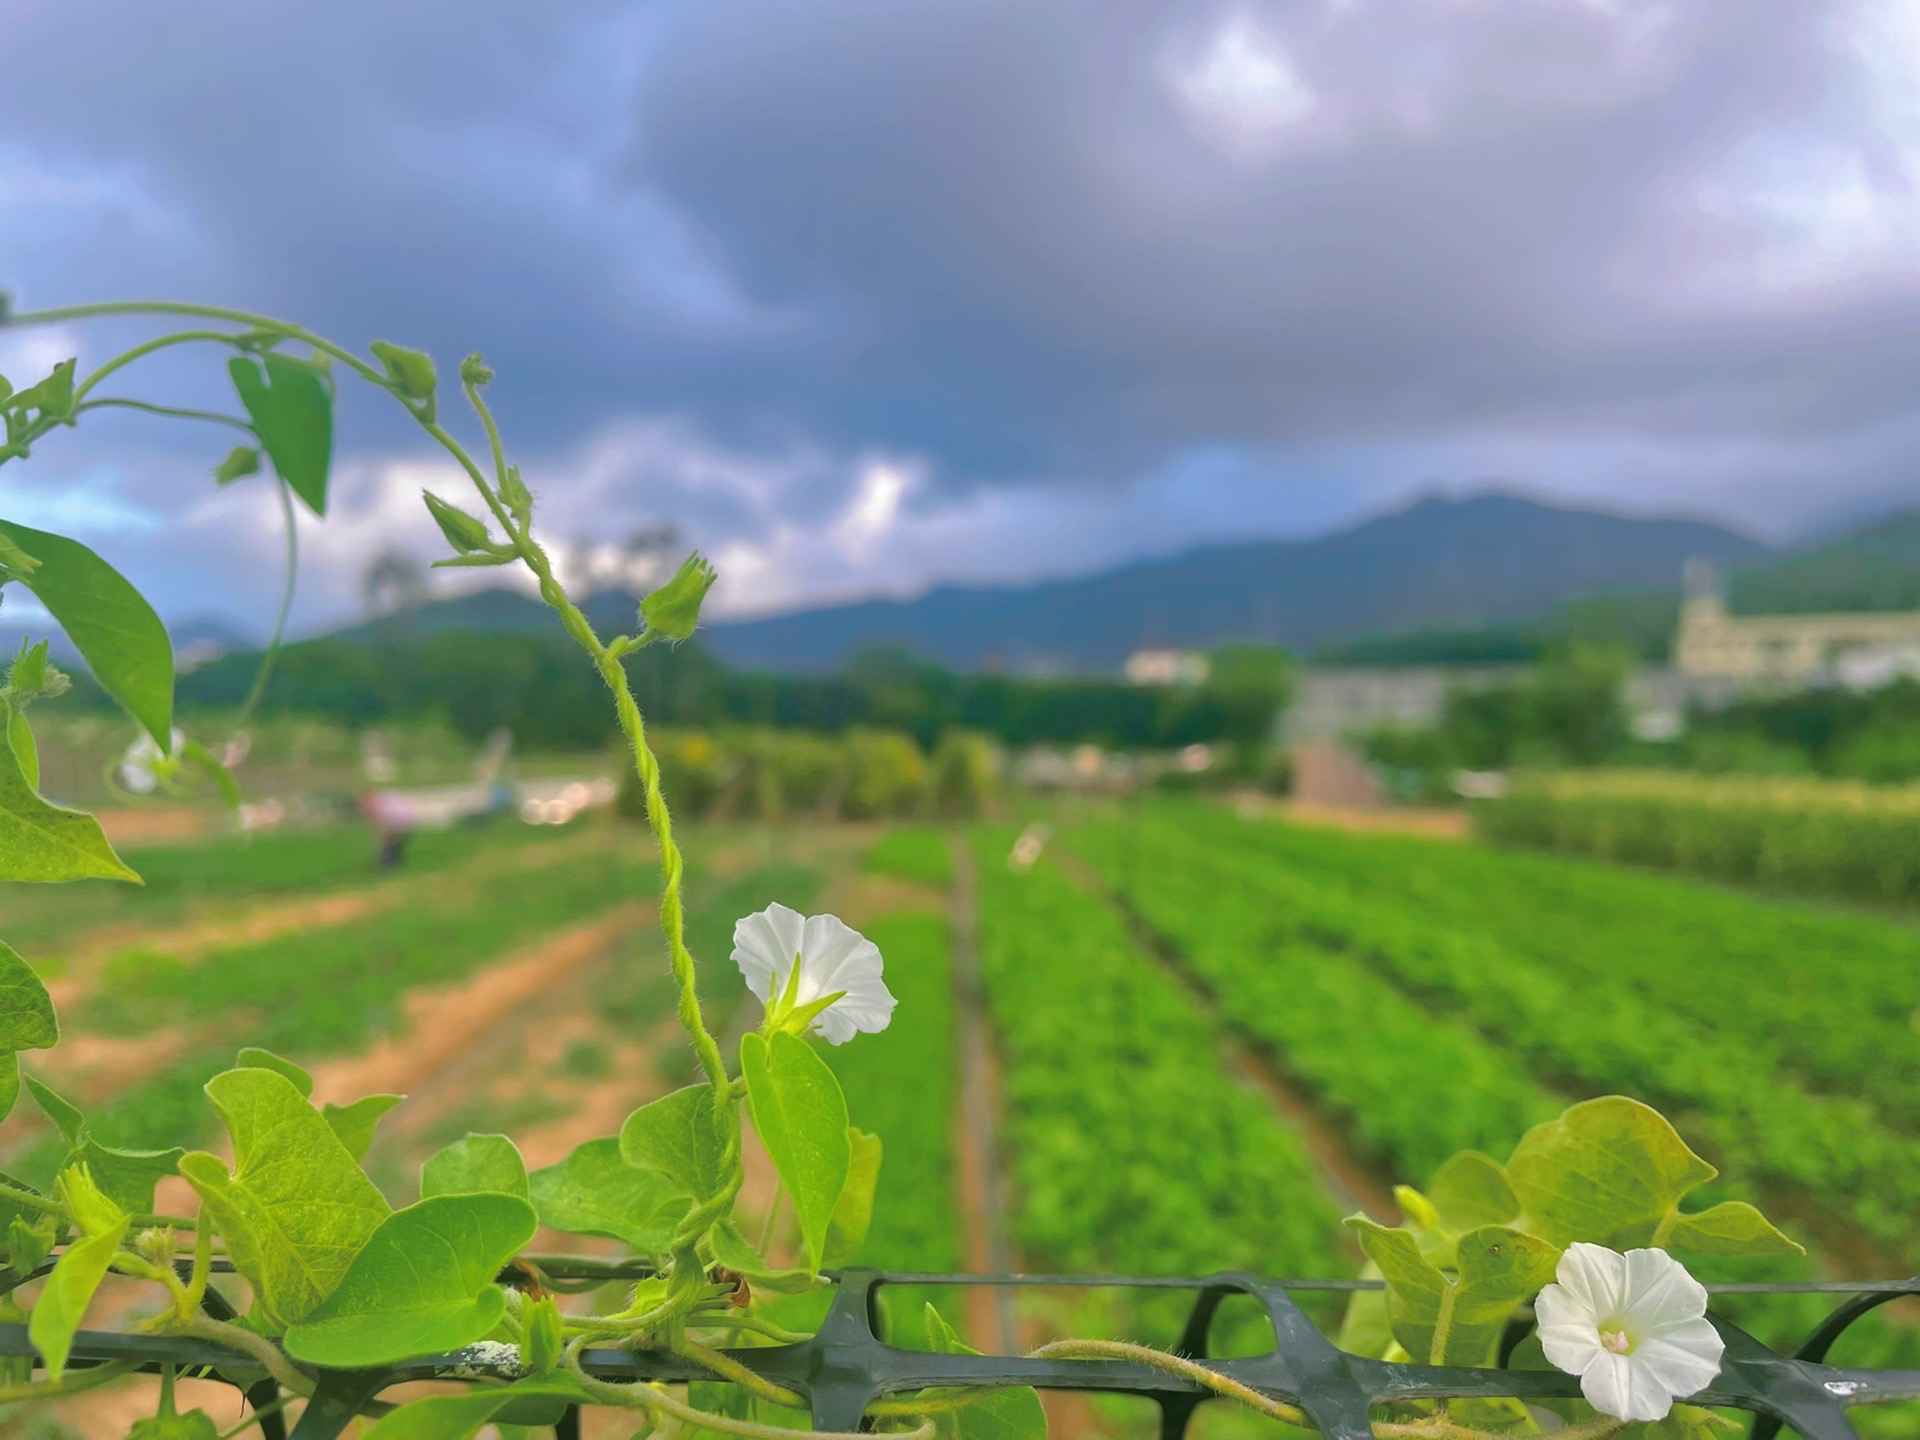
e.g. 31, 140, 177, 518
1181, 812, 1920, 1133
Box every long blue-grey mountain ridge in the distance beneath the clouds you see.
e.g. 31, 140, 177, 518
703, 493, 1770, 672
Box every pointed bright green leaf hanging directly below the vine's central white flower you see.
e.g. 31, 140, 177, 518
739, 1031, 852, 1269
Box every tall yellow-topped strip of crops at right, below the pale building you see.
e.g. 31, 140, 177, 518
1475, 772, 1920, 902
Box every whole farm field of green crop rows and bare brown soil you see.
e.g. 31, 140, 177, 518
0, 801, 1920, 1436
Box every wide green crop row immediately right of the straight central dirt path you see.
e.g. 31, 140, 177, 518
979, 833, 1350, 1305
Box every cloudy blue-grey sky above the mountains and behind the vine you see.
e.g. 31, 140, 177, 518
0, 0, 1920, 628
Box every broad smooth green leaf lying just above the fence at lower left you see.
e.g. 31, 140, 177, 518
286, 1194, 540, 1367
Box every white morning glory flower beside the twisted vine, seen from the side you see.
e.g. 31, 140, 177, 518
733, 904, 899, 1044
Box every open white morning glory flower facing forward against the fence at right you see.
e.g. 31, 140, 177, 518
1534, 1244, 1726, 1421
